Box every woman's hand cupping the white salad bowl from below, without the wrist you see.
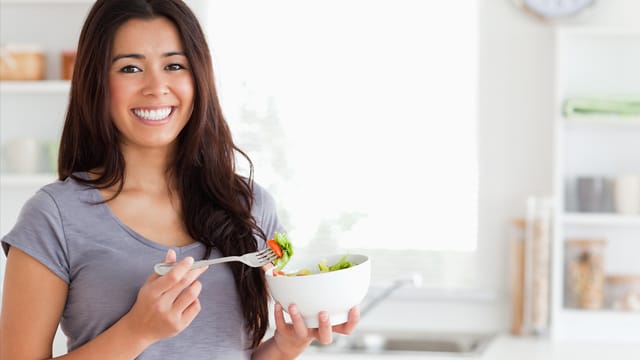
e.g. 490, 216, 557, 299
273, 303, 360, 356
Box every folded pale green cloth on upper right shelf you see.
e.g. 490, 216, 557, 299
563, 97, 640, 116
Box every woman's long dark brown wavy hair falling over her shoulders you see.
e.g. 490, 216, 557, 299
58, 0, 268, 347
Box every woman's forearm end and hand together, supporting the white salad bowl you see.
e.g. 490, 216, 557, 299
252, 303, 360, 360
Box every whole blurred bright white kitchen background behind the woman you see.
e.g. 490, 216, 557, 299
0, 0, 640, 358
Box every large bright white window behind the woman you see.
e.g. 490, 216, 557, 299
207, 0, 478, 286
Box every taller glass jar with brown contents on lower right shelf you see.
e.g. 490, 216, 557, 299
565, 239, 606, 309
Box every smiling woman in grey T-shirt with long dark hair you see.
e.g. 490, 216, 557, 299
0, 0, 358, 360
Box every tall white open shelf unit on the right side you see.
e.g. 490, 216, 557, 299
551, 27, 640, 342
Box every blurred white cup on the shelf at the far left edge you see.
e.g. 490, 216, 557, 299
3, 138, 41, 174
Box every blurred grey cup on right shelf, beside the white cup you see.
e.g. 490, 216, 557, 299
576, 176, 613, 212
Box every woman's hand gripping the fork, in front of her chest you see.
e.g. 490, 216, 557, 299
123, 250, 207, 344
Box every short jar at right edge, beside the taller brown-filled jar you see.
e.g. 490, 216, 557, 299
606, 274, 640, 311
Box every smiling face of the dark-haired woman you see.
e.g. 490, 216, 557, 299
109, 17, 194, 149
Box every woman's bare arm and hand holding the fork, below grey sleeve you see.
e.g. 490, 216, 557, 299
0, 247, 206, 360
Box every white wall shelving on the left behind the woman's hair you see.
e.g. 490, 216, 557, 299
0, 0, 93, 235
